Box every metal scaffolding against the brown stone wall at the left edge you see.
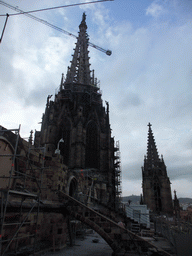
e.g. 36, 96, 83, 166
0, 125, 45, 256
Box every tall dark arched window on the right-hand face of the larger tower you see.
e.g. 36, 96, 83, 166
85, 121, 99, 168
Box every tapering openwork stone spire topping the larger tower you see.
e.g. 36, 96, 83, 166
65, 13, 91, 85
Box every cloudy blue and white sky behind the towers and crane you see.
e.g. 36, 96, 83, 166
0, 0, 192, 197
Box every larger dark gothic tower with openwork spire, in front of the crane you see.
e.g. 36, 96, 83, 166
35, 13, 117, 206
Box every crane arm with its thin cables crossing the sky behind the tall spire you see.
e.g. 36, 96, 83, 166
0, 0, 113, 56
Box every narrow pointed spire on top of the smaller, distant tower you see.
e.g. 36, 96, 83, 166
146, 123, 160, 167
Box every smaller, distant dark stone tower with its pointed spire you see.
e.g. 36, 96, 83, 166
142, 123, 173, 214
